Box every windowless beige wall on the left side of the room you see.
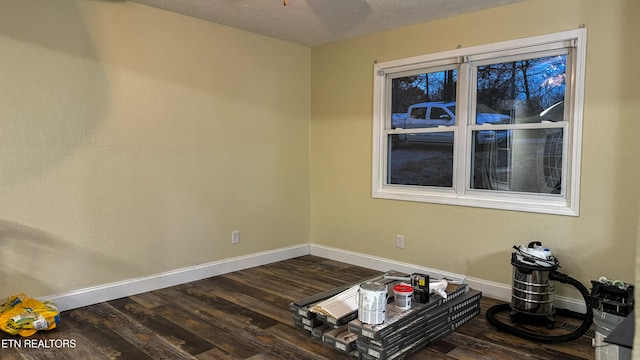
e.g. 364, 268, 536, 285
0, 0, 310, 297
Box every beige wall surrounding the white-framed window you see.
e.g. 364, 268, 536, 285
310, 0, 640, 297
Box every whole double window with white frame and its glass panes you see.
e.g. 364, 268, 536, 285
372, 29, 586, 216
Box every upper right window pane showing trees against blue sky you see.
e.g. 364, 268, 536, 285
476, 55, 567, 124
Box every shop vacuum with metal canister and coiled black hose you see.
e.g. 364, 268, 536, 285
486, 241, 593, 343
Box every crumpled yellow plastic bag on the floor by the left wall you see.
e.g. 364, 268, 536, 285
0, 294, 60, 337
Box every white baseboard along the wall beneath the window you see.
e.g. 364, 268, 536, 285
310, 244, 586, 313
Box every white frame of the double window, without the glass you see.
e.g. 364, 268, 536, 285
372, 28, 587, 216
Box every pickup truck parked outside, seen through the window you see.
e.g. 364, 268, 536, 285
391, 102, 510, 146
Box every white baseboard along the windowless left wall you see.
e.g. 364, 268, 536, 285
42, 244, 309, 311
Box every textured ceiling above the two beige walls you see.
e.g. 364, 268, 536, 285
131, 0, 521, 46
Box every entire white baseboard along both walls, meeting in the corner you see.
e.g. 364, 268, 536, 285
42, 244, 585, 313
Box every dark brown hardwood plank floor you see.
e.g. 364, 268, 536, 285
0, 256, 595, 360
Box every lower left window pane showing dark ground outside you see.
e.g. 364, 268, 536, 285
387, 132, 453, 188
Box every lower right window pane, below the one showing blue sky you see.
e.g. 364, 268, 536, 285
471, 128, 563, 194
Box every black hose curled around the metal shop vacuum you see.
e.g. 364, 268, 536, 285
486, 270, 593, 344
